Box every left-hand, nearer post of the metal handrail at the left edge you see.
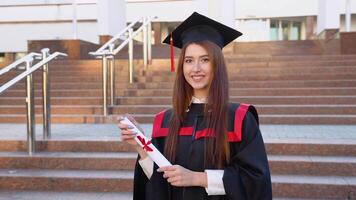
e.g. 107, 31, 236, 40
26, 58, 36, 156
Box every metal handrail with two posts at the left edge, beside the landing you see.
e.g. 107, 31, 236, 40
0, 48, 67, 156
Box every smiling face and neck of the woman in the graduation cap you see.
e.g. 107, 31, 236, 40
183, 43, 213, 98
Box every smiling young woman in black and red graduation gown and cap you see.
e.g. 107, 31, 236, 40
118, 13, 272, 200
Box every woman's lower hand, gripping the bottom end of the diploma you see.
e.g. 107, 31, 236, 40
158, 165, 208, 187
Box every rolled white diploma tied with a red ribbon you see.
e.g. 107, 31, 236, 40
121, 116, 172, 167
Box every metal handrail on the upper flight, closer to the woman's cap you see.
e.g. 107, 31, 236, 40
89, 17, 157, 116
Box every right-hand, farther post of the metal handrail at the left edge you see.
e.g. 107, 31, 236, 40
41, 48, 51, 140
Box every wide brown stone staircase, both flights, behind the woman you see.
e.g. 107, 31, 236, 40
0, 42, 356, 200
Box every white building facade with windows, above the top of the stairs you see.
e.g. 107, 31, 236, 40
0, 0, 356, 53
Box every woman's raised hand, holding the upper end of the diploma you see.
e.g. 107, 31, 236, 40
117, 115, 147, 159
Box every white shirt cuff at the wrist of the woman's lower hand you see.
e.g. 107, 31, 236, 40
205, 170, 226, 195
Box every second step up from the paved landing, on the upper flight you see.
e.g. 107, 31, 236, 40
0, 104, 356, 115
